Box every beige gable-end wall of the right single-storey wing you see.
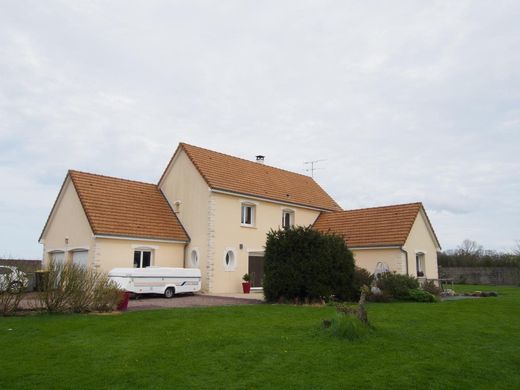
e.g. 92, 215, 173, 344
403, 212, 439, 279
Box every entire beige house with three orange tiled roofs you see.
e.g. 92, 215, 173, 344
40, 143, 439, 293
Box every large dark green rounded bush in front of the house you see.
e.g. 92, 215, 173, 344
263, 227, 356, 302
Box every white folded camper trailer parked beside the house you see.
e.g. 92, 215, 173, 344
108, 267, 200, 298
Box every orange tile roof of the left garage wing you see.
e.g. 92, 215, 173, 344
69, 170, 189, 241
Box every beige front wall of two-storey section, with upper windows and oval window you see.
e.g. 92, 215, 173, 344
211, 193, 319, 293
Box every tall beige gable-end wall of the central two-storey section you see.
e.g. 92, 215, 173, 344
160, 149, 212, 291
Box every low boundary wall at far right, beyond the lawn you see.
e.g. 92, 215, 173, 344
439, 267, 520, 286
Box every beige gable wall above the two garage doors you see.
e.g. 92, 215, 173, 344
42, 178, 94, 264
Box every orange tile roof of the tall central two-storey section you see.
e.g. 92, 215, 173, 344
161, 143, 341, 210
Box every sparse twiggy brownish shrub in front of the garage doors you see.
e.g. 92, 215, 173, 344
38, 260, 122, 313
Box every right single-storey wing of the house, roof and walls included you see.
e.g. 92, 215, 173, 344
313, 203, 441, 279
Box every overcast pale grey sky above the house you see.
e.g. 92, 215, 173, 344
0, 0, 520, 258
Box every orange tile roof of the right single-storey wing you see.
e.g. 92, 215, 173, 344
313, 203, 426, 248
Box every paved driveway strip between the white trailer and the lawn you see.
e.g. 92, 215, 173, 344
128, 294, 262, 311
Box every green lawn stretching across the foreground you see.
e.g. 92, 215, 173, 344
0, 286, 520, 389
